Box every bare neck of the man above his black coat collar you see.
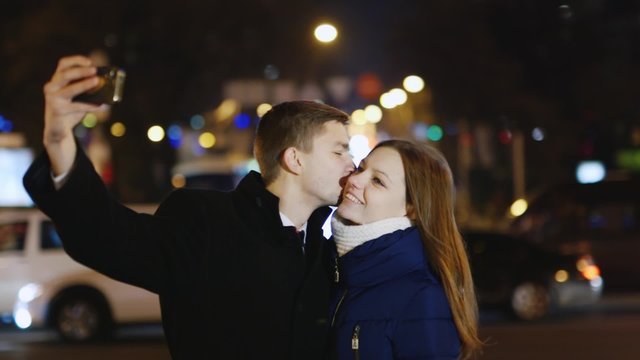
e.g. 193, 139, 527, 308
267, 177, 317, 228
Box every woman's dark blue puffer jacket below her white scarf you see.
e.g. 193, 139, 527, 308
330, 227, 460, 360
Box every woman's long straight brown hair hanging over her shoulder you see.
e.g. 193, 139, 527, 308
374, 140, 482, 359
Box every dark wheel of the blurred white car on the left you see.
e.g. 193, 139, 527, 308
53, 294, 111, 342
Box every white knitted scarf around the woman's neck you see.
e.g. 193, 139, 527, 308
331, 214, 413, 256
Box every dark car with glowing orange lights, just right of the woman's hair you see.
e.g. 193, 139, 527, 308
463, 231, 604, 321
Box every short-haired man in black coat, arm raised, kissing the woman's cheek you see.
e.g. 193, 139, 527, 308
24, 56, 353, 360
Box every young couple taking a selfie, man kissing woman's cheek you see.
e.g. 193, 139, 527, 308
24, 56, 480, 360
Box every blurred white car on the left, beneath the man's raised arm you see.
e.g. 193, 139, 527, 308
0, 205, 161, 342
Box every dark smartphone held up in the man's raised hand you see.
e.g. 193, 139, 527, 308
73, 66, 127, 105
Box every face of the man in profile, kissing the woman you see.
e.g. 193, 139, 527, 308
301, 121, 354, 207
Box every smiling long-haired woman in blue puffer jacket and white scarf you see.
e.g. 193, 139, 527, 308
330, 140, 481, 360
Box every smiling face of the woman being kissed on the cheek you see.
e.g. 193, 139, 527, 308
337, 147, 407, 224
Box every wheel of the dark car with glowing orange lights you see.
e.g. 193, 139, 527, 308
511, 282, 549, 320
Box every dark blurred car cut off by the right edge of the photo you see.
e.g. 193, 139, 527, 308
509, 180, 640, 292
